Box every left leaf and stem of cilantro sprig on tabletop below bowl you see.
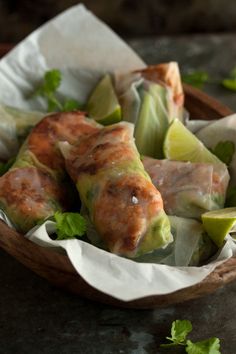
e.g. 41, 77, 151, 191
161, 320, 192, 347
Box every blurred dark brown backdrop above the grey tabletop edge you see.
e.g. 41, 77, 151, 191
0, 0, 236, 43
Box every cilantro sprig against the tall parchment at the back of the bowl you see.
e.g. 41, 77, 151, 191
33, 69, 82, 112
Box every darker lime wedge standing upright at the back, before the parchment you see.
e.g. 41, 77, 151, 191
87, 74, 121, 125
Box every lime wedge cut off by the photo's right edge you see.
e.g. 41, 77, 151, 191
202, 207, 236, 247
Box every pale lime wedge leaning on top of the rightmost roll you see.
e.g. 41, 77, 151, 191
163, 119, 222, 164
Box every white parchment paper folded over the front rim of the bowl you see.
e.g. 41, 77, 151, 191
26, 221, 236, 301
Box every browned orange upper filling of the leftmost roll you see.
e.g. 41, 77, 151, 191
28, 112, 98, 170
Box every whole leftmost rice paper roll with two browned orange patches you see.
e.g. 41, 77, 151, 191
0, 112, 99, 233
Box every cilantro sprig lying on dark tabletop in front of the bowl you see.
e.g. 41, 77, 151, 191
161, 320, 221, 354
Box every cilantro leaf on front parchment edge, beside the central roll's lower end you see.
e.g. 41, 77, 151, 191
54, 211, 86, 240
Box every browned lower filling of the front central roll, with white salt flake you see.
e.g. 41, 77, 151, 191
94, 174, 163, 254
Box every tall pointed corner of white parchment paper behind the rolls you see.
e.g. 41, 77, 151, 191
0, 5, 145, 110
